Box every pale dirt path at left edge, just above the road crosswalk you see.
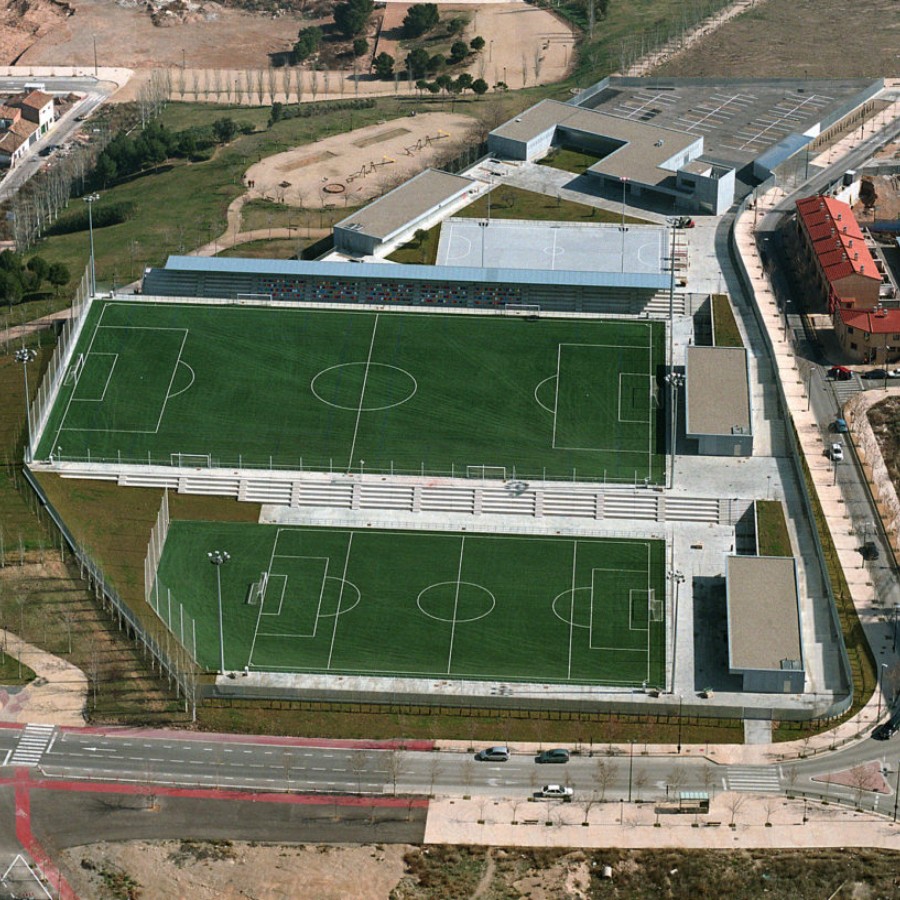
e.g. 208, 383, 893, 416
0, 629, 88, 725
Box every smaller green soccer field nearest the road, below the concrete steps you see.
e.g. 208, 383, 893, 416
152, 522, 666, 686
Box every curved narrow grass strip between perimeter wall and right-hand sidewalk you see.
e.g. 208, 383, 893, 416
773, 438, 877, 741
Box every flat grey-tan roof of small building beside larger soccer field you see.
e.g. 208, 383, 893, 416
685, 347, 752, 435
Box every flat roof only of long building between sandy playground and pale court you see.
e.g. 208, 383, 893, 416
334, 169, 475, 240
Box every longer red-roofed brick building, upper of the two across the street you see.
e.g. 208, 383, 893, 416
797, 197, 882, 313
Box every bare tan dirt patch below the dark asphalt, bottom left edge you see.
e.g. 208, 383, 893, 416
61, 841, 409, 900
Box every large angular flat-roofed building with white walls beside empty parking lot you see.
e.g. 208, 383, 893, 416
488, 100, 734, 215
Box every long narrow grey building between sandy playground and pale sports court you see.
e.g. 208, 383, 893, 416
334, 169, 477, 256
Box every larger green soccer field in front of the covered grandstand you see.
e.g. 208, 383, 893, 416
36, 301, 665, 483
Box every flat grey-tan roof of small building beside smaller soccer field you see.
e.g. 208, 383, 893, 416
727, 556, 803, 671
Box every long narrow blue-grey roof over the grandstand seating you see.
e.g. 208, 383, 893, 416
160, 256, 669, 291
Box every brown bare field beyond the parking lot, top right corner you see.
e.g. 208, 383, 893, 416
654, 0, 900, 78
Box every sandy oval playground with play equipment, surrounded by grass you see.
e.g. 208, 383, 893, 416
244, 113, 475, 209
